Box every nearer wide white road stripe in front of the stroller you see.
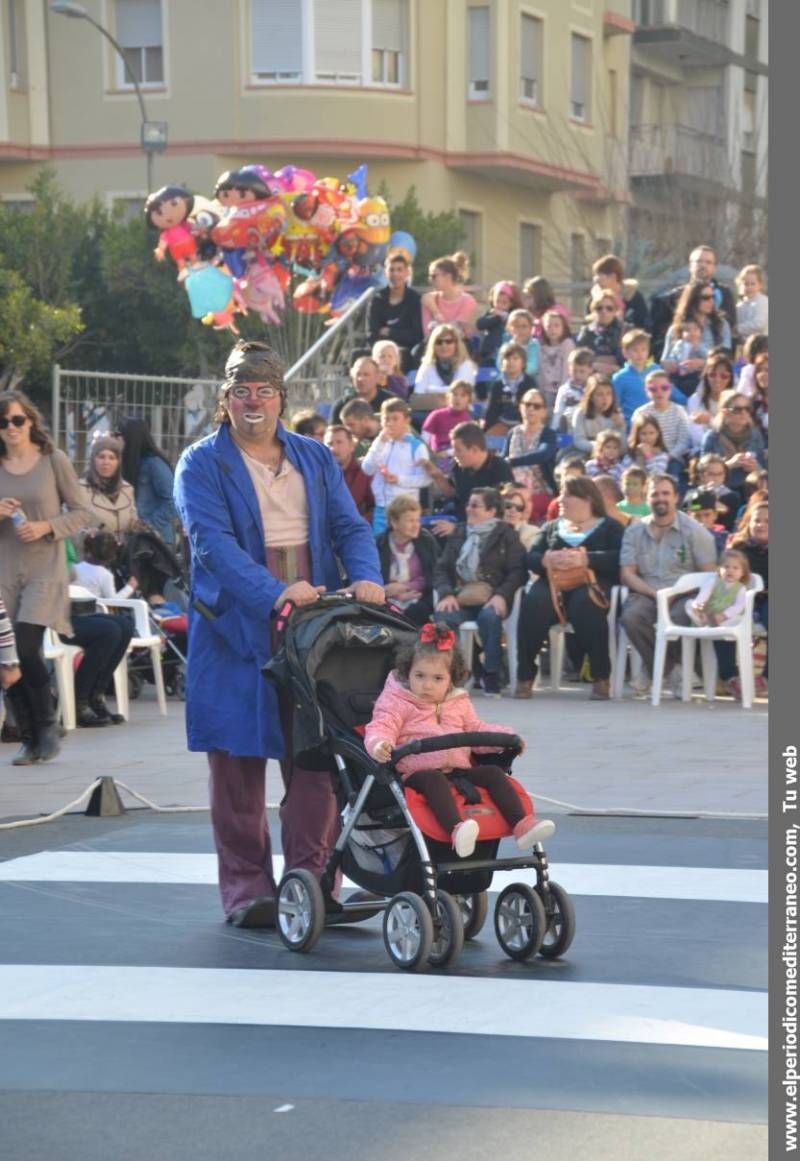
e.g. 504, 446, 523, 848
0, 952, 767, 1052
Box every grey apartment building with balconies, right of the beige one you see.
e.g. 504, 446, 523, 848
629, 0, 769, 264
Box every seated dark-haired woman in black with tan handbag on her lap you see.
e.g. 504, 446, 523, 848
514, 476, 624, 701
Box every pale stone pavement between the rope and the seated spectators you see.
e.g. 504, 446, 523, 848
0, 685, 767, 826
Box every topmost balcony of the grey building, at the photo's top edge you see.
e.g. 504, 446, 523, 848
633, 0, 743, 68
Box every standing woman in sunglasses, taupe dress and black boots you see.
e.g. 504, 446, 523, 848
0, 391, 89, 766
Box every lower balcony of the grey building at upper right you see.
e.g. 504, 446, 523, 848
629, 124, 731, 186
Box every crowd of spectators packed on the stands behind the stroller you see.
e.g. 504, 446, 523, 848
341, 245, 769, 700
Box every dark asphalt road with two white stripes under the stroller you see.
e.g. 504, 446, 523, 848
0, 810, 766, 1161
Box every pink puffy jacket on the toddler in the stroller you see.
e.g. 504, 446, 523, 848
363, 672, 513, 778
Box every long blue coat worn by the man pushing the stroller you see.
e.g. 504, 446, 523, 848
175, 424, 383, 758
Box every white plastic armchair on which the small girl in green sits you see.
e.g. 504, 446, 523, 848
650, 572, 764, 709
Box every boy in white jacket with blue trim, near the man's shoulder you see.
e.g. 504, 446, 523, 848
361, 399, 430, 536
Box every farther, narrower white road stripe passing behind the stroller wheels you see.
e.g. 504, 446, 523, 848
0, 851, 767, 903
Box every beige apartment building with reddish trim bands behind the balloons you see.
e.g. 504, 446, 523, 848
0, 0, 634, 283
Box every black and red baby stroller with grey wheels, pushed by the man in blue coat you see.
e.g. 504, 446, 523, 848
264, 593, 575, 971
